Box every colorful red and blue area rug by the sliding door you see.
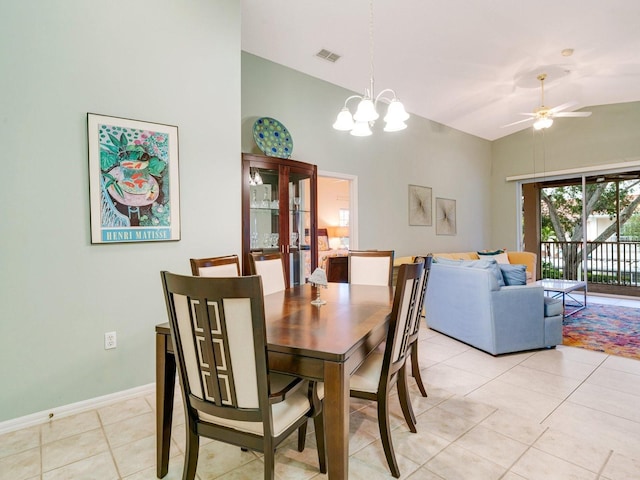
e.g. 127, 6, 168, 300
562, 304, 640, 360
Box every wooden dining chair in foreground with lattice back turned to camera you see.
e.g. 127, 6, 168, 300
161, 271, 326, 480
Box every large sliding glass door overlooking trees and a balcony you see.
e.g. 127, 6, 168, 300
522, 172, 640, 295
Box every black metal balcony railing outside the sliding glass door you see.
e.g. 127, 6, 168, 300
540, 242, 640, 287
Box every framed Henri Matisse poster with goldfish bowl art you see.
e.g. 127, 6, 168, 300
87, 113, 180, 243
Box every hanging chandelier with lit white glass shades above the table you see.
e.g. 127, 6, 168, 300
333, 0, 409, 137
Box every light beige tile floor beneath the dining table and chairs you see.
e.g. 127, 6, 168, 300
0, 297, 640, 480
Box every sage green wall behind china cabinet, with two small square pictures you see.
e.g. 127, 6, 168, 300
242, 52, 491, 256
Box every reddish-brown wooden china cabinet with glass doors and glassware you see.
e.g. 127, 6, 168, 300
242, 153, 318, 286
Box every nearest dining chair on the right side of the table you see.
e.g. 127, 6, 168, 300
349, 262, 424, 478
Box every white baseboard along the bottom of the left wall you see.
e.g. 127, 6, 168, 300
0, 383, 156, 435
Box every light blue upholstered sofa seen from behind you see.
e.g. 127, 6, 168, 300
425, 260, 563, 355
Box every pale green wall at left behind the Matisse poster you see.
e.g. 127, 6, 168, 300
0, 0, 241, 421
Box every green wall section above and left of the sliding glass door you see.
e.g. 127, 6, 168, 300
490, 102, 640, 248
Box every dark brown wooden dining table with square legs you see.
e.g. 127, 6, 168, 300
156, 283, 393, 480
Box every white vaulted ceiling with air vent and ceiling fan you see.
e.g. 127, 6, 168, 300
242, 0, 640, 140
